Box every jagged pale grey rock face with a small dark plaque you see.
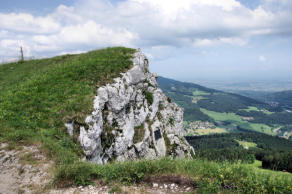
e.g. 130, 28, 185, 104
66, 51, 194, 163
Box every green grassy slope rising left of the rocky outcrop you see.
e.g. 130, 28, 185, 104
0, 47, 135, 162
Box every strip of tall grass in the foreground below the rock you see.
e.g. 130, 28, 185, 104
55, 158, 292, 194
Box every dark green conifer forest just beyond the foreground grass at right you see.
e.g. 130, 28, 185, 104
186, 132, 292, 172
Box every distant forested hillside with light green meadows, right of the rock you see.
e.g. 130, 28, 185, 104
158, 77, 292, 138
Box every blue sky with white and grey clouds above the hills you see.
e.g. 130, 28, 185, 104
0, 0, 292, 81
